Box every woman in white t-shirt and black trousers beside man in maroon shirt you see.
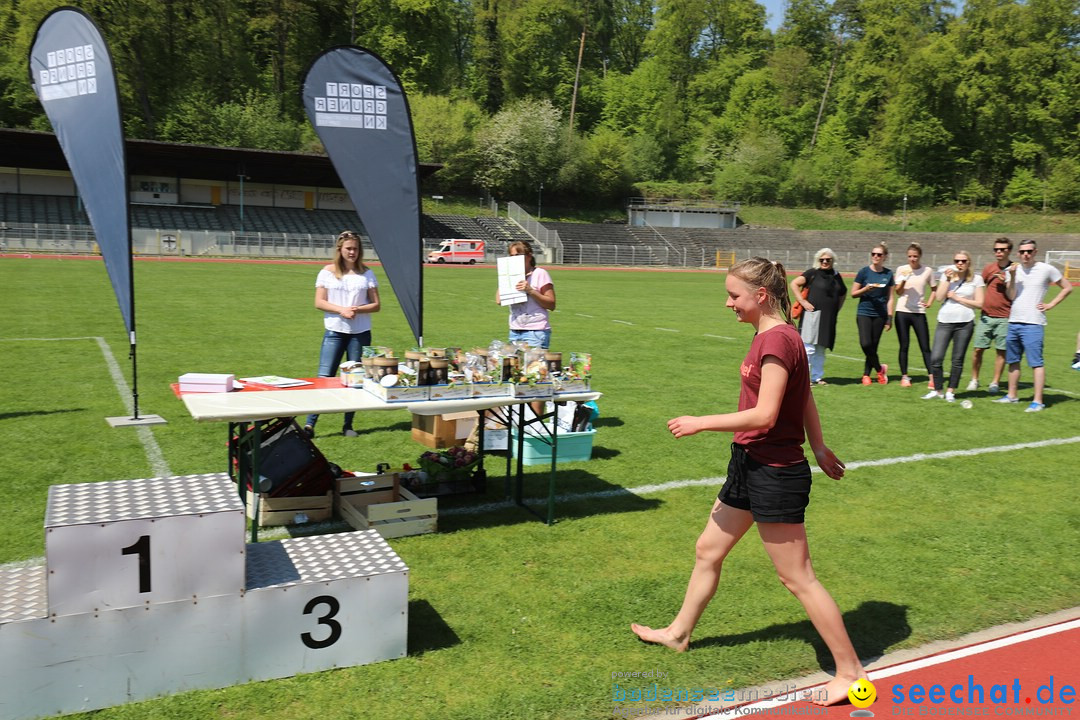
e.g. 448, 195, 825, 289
922, 250, 985, 403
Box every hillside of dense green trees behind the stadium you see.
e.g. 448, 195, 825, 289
0, 0, 1080, 210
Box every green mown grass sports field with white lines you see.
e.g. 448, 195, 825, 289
0, 258, 1080, 720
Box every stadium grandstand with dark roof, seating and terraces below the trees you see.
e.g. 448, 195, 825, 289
0, 128, 1080, 271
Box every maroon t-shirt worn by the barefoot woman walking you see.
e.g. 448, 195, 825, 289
734, 324, 810, 467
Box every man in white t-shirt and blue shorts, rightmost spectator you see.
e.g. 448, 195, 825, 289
994, 240, 1072, 412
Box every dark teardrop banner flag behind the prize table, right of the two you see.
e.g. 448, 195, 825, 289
300, 45, 423, 344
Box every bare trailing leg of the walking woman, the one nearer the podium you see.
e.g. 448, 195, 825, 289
630, 500, 754, 652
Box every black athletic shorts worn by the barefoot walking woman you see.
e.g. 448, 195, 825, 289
716, 443, 810, 522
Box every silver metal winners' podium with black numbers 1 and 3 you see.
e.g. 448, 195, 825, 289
0, 473, 408, 720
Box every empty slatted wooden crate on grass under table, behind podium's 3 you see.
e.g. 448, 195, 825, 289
334, 473, 438, 539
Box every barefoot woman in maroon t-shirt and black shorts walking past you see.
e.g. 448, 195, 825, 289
631, 258, 866, 705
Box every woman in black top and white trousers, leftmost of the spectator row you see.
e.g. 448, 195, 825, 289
792, 247, 848, 385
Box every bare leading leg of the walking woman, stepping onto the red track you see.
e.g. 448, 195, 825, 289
757, 522, 866, 705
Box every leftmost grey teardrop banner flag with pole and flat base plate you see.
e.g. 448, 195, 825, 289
29, 8, 162, 424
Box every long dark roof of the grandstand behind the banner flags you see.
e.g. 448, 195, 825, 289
0, 128, 442, 188
